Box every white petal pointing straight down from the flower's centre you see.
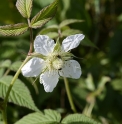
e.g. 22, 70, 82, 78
40, 71, 59, 92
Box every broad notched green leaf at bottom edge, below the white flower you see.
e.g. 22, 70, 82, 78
15, 109, 61, 124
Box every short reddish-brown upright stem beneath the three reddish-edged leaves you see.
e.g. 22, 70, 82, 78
27, 19, 34, 55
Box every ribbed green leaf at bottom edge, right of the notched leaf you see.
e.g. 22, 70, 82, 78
61, 114, 100, 124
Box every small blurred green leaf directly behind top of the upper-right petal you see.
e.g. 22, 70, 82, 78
62, 29, 82, 37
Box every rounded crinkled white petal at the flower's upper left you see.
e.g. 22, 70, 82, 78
34, 35, 55, 55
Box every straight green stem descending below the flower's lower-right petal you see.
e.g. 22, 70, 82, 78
64, 78, 77, 113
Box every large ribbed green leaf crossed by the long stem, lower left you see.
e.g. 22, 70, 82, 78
0, 76, 39, 111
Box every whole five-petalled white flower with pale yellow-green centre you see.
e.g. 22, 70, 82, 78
21, 34, 84, 92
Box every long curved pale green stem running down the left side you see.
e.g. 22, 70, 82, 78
2, 56, 31, 124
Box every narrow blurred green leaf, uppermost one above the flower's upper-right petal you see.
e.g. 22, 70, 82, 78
59, 19, 83, 28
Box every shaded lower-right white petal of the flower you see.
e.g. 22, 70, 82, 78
59, 60, 82, 79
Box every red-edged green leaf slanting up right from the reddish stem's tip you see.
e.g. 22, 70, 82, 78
31, 0, 58, 28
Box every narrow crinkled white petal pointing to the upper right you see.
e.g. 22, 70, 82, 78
62, 34, 85, 52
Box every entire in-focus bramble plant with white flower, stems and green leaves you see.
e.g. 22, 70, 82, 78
0, 0, 98, 124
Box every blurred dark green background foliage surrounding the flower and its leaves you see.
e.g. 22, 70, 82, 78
0, 0, 122, 124
